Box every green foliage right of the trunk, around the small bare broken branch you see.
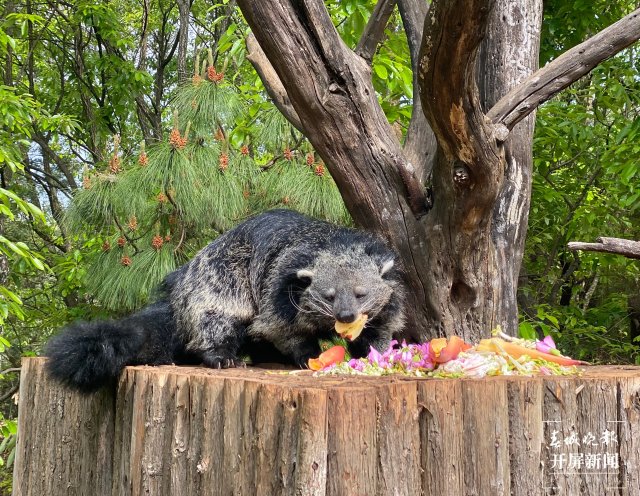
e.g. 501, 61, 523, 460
519, 11, 640, 363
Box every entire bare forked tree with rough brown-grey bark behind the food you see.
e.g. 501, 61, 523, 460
238, 0, 640, 340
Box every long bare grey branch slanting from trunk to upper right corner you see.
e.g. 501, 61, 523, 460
487, 9, 640, 130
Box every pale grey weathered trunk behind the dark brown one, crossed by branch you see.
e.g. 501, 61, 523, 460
478, 0, 542, 335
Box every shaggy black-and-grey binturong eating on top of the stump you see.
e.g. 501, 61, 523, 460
46, 210, 405, 392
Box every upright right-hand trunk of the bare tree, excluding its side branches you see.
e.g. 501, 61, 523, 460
421, 0, 542, 341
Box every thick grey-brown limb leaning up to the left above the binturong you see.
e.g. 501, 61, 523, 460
238, 0, 425, 219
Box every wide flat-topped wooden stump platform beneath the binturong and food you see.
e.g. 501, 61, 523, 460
14, 358, 640, 496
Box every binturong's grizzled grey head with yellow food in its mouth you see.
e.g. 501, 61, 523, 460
297, 245, 397, 340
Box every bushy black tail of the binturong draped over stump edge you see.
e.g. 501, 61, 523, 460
45, 302, 175, 393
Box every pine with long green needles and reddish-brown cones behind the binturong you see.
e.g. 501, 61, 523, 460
66, 47, 349, 311
